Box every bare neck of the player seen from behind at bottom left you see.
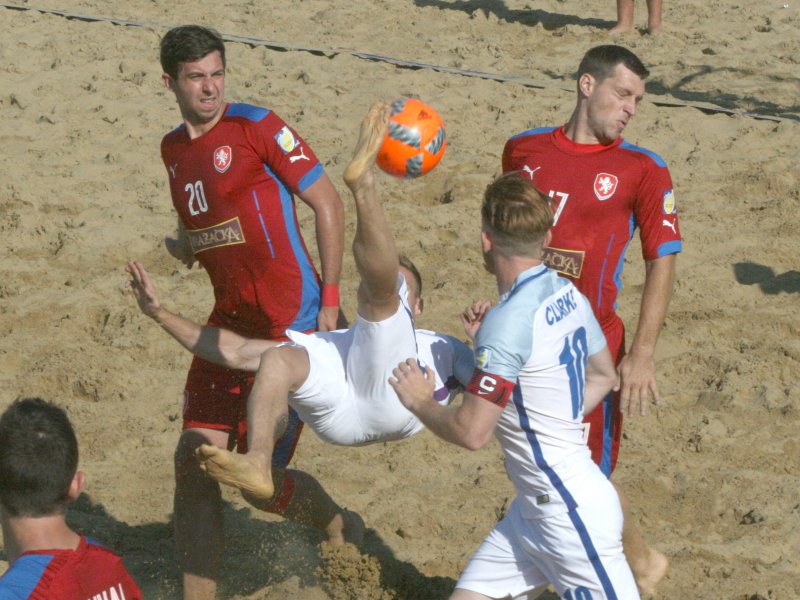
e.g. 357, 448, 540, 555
3, 515, 80, 564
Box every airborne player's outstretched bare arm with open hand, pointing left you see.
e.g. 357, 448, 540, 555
125, 261, 278, 371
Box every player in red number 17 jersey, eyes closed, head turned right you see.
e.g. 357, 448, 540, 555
503, 46, 681, 592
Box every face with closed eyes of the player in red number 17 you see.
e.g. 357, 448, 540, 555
581, 64, 644, 144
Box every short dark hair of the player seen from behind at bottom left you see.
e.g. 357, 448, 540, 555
0, 398, 78, 517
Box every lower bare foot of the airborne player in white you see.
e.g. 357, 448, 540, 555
195, 444, 275, 500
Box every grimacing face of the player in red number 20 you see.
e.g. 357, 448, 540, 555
163, 50, 225, 128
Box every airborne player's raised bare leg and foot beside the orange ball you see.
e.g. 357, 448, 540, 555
344, 102, 400, 321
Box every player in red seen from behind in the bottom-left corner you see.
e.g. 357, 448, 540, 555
0, 398, 142, 600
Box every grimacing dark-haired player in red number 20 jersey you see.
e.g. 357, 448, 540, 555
161, 25, 346, 598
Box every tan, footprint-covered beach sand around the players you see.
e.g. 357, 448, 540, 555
0, 0, 800, 600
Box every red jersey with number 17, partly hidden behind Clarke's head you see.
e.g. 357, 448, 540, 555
503, 127, 681, 329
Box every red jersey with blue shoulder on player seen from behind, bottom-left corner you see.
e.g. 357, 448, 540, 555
0, 536, 142, 600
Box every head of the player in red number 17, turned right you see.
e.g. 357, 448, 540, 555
576, 45, 650, 144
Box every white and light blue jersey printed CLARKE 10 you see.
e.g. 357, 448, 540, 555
475, 265, 606, 517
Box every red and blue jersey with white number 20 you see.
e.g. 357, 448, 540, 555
161, 104, 323, 337
